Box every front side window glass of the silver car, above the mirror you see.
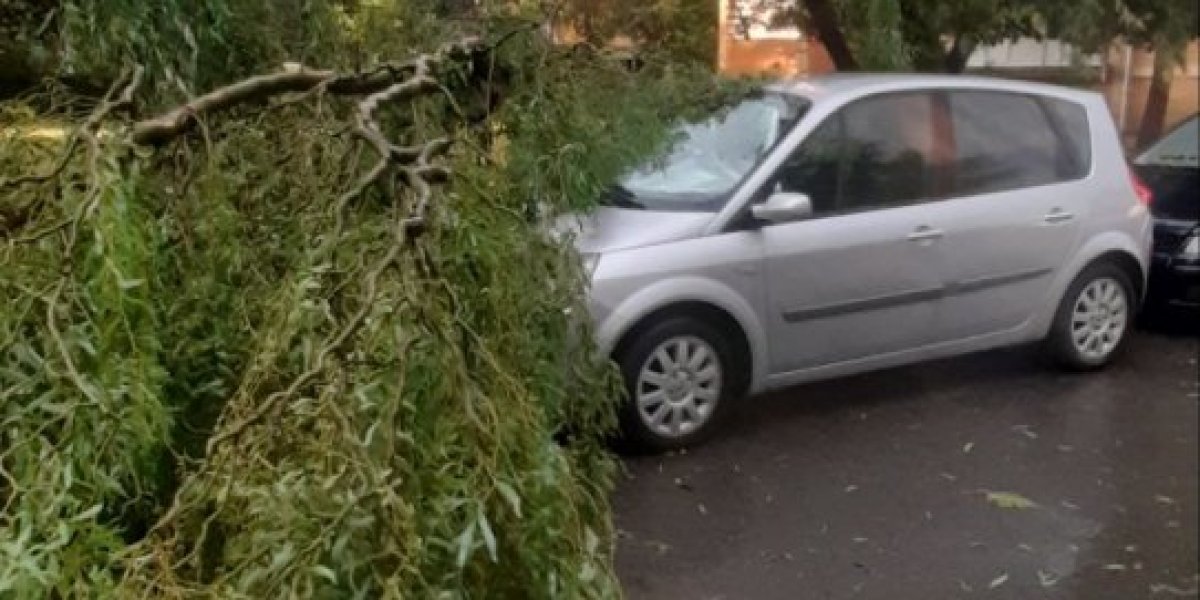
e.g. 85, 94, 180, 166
774, 92, 937, 216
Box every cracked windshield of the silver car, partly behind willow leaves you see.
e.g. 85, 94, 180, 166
612, 94, 808, 211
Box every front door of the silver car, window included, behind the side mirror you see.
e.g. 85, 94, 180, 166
760, 92, 944, 374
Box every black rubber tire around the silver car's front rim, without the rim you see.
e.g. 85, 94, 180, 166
614, 316, 744, 452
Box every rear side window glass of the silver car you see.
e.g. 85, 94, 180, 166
947, 91, 1091, 196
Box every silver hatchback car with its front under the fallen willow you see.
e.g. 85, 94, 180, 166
570, 74, 1151, 450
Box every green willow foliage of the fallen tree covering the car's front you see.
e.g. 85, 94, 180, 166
0, 0, 748, 599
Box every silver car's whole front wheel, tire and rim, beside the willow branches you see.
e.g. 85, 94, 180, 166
617, 317, 736, 451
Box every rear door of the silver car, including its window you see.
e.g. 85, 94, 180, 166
937, 90, 1091, 340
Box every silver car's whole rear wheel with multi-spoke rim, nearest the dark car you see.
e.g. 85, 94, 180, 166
1046, 263, 1136, 371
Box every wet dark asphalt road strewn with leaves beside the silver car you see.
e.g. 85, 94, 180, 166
614, 316, 1200, 600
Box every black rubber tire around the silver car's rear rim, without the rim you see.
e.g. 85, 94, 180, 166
1043, 263, 1138, 372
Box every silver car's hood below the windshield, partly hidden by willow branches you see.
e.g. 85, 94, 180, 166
554, 206, 714, 253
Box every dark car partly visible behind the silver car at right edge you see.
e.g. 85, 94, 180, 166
1134, 115, 1200, 310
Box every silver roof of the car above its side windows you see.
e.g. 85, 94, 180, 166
769, 73, 1097, 101
